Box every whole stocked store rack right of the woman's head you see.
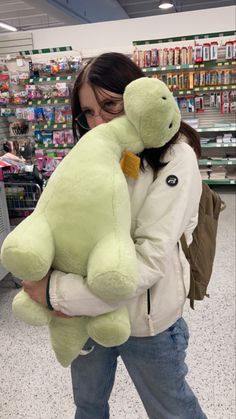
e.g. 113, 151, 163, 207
133, 31, 236, 185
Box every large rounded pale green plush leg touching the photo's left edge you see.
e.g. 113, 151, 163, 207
1, 213, 54, 281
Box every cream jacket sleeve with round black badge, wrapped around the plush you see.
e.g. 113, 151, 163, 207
50, 144, 202, 316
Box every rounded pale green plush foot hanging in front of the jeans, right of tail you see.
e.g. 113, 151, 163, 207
87, 307, 131, 348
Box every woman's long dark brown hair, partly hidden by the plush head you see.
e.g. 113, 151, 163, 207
71, 52, 201, 172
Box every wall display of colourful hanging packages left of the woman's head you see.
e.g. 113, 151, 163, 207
0, 47, 82, 173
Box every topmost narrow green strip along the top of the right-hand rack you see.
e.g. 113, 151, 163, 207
133, 31, 236, 46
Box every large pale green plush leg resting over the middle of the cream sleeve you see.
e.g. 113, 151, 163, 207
87, 233, 138, 301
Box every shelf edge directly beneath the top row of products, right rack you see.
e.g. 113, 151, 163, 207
141, 60, 236, 73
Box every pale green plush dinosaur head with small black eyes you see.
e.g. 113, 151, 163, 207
124, 77, 181, 148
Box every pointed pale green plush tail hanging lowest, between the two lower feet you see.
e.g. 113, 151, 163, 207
49, 317, 89, 368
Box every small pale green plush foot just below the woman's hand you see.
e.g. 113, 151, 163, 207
12, 290, 52, 326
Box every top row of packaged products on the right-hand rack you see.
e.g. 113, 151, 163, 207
133, 40, 236, 68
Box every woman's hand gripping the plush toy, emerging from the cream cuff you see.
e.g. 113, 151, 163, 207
22, 270, 71, 319
